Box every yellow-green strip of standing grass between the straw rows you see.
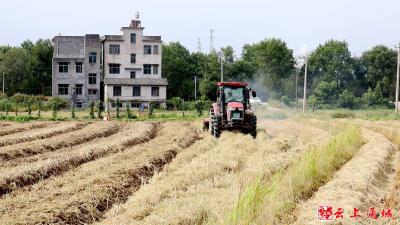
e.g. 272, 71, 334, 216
227, 126, 363, 224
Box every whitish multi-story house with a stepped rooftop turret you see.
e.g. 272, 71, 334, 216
101, 18, 168, 108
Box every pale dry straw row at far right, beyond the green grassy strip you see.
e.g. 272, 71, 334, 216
296, 129, 397, 224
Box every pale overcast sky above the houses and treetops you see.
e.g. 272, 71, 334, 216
0, 0, 400, 56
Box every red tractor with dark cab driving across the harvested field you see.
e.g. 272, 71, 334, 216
203, 82, 257, 138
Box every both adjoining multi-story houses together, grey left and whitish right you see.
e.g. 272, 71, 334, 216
52, 17, 168, 109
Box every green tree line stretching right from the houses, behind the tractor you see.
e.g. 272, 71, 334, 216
162, 38, 397, 109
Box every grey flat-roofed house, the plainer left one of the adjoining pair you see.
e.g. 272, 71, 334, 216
52, 34, 101, 107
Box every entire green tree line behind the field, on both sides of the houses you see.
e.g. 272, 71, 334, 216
0, 38, 397, 108
